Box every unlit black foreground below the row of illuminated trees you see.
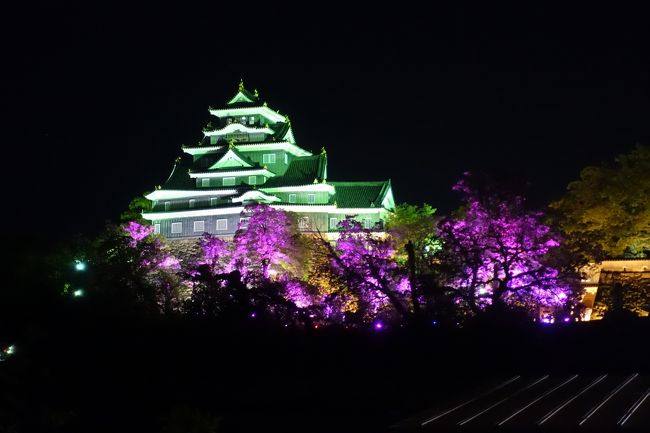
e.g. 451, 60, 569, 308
0, 305, 650, 432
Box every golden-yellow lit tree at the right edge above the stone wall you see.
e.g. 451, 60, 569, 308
550, 145, 650, 261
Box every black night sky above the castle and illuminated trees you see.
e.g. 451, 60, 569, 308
0, 2, 650, 238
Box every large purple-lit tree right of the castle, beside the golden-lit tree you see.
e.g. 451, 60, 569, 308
439, 176, 572, 314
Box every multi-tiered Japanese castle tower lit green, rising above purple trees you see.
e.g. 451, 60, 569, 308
143, 82, 394, 239
